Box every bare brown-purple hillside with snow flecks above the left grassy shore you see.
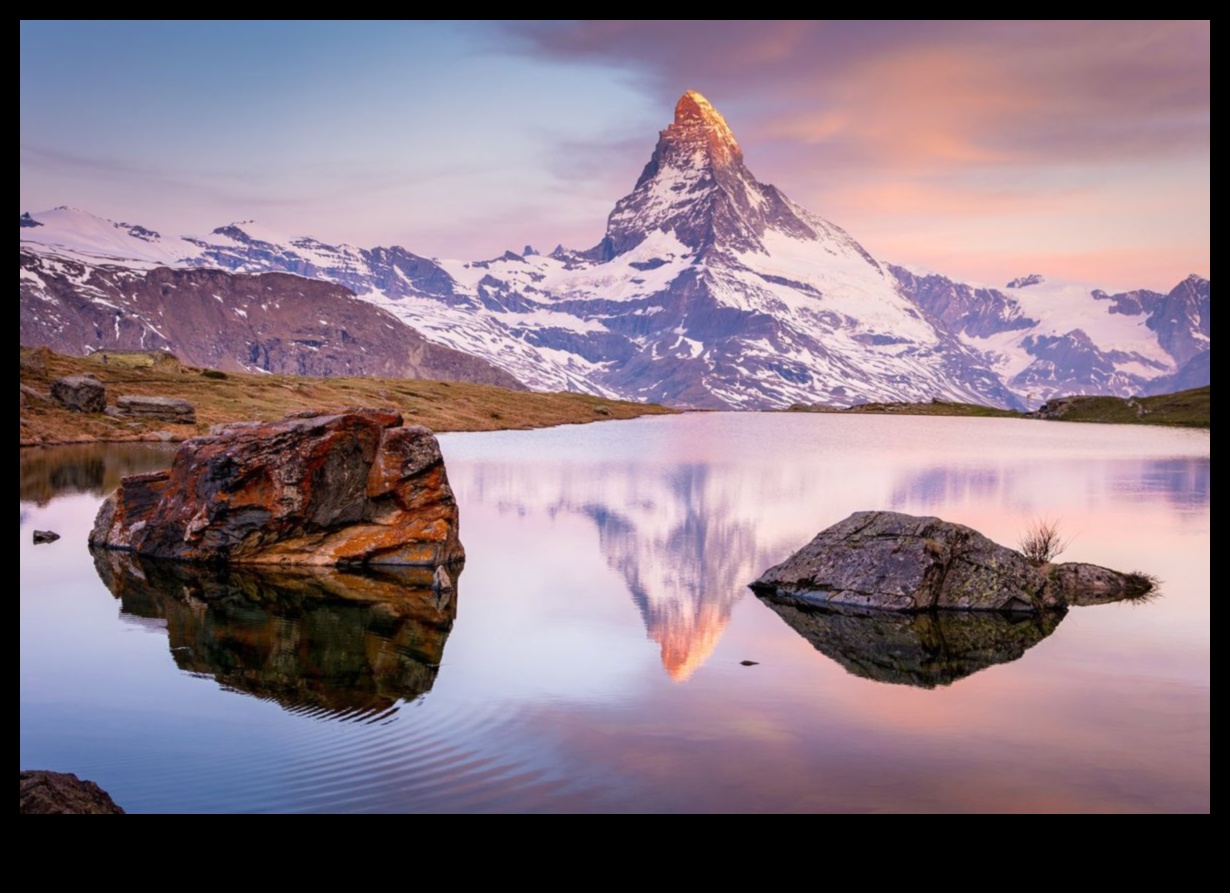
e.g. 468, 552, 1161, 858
20, 250, 525, 390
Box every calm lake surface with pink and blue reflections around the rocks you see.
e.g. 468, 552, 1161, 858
21, 413, 1209, 812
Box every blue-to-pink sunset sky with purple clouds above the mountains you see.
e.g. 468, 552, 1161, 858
21, 21, 1210, 290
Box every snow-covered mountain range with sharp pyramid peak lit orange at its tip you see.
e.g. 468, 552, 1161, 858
21, 91, 1209, 408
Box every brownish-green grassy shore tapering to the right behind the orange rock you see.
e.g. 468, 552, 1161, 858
20, 348, 674, 447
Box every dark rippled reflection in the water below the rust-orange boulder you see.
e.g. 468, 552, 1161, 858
93, 550, 460, 721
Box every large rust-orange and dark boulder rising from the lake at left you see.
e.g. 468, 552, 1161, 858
90, 410, 465, 567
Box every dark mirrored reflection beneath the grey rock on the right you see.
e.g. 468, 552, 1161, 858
759, 595, 1065, 689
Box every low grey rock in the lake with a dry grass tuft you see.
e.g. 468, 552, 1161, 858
752, 512, 1154, 611
